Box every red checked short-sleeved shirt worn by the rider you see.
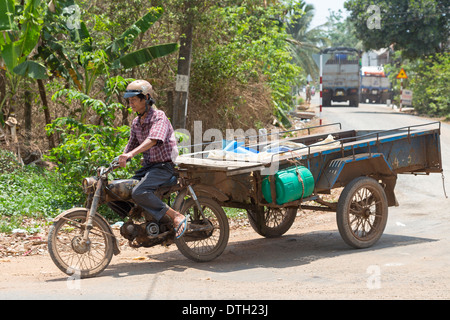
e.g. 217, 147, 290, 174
125, 109, 178, 164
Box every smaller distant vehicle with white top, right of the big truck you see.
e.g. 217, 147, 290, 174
361, 66, 391, 103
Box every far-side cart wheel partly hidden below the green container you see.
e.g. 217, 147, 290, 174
247, 207, 298, 238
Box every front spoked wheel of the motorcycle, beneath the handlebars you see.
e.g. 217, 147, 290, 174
48, 210, 113, 279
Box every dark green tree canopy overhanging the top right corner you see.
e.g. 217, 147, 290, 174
344, 0, 450, 58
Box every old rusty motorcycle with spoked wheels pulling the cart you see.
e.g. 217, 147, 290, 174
48, 158, 229, 278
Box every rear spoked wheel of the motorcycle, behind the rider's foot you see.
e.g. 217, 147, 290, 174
175, 197, 230, 262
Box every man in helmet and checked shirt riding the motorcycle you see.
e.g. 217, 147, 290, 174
119, 80, 187, 238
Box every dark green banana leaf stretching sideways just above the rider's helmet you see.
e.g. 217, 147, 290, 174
113, 43, 179, 69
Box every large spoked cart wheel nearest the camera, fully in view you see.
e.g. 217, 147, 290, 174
336, 177, 388, 248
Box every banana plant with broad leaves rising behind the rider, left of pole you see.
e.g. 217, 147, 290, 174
39, 0, 178, 123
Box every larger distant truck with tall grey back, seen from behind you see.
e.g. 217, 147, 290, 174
321, 47, 361, 107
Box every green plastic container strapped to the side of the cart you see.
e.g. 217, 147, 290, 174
262, 166, 314, 204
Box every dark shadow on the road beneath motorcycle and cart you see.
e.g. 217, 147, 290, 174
100, 231, 437, 277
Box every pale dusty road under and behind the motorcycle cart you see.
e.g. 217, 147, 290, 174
0, 104, 450, 300
